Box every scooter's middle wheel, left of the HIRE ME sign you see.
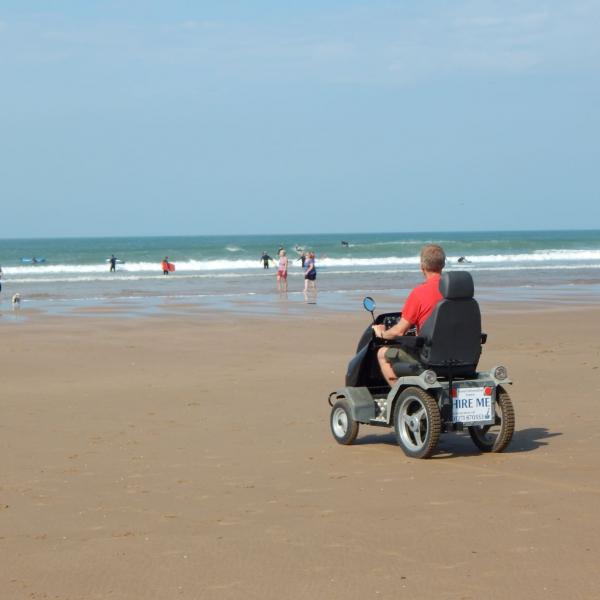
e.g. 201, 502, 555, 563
394, 387, 442, 458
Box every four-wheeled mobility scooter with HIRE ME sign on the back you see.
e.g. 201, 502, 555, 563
329, 271, 515, 458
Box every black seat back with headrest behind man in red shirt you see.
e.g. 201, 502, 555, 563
419, 271, 481, 377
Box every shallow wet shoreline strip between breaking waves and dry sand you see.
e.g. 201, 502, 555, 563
0, 280, 600, 323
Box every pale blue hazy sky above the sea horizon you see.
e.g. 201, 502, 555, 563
0, 0, 600, 238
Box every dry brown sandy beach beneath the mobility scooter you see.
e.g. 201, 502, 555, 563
0, 306, 600, 600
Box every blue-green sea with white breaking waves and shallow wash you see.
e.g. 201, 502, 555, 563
0, 230, 600, 314
